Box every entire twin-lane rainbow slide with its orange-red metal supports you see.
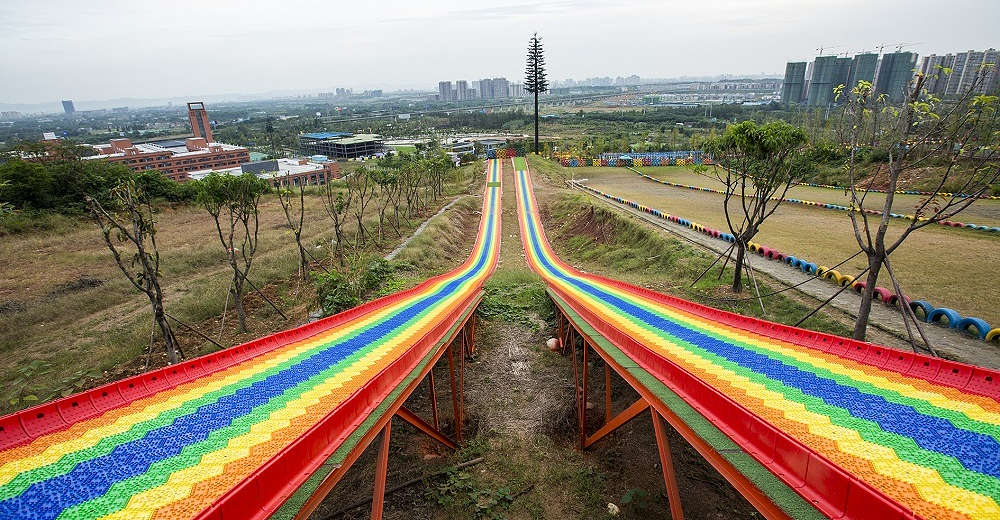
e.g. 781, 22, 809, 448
0, 158, 1000, 520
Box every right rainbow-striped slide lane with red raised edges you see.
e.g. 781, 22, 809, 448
515, 159, 1000, 520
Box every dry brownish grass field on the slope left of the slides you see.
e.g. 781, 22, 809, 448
0, 167, 478, 411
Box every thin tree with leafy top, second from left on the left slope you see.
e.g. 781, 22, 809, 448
197, 173, 271, 332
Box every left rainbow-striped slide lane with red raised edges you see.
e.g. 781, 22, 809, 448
0, 160, 501, 520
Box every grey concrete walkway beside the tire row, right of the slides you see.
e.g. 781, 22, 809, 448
577, 183, 1000, 369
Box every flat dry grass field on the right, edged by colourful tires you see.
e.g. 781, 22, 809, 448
575, 168, 1000, 326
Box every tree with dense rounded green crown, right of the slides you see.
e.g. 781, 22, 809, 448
701, 121, 807, 292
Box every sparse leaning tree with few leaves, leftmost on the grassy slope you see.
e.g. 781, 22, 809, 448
87, 179, 183, 363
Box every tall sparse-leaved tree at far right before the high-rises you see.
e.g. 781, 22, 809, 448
837, 66, 1000, 346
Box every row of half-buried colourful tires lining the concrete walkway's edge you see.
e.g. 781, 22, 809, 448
573, 182, 1000, 341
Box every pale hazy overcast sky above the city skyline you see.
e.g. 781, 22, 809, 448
0, 0, 1000, 103
